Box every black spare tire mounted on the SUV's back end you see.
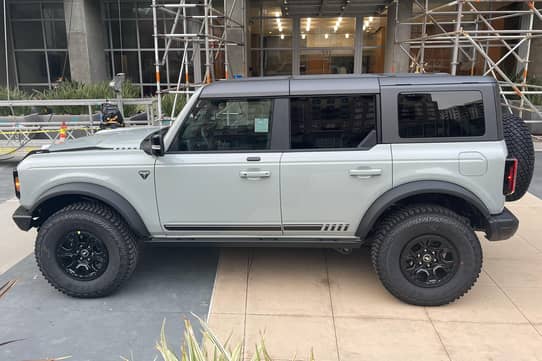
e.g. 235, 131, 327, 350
503, 113, 535, 202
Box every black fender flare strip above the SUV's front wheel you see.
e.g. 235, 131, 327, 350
29, 182, 150, 237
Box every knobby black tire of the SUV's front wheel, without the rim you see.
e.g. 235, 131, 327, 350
35, 202, 139, 298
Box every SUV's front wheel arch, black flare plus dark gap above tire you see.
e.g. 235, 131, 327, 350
29, 182, 150, 237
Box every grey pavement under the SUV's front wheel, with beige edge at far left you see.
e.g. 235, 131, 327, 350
0, 201, 218, 361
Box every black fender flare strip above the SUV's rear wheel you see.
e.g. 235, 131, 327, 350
356, 181, 490, 240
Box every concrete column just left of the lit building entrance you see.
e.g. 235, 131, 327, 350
224, 0, 248, 77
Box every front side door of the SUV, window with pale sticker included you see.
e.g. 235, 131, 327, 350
155, 98, 282, 237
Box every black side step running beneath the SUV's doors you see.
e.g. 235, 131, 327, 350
145, 237, 363, 248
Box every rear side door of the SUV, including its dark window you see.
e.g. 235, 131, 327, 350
281, 94, 392, 239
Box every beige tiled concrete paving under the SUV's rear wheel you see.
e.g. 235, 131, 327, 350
210, 194, 542, 361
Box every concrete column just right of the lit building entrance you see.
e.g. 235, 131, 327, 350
384, 0, 412, 73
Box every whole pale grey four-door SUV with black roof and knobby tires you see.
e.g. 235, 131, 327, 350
13, 74, 534, 305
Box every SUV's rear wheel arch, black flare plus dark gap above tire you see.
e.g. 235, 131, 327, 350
356, 181, 490, 240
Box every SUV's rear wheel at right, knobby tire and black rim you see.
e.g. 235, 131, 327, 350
371, 205, 482, 306
